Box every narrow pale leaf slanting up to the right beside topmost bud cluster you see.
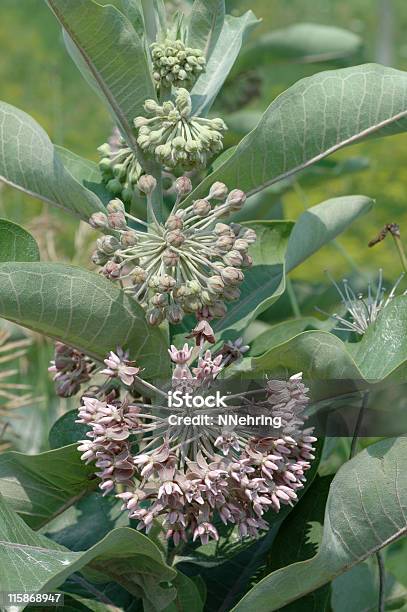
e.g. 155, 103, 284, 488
191, 11, 258, 115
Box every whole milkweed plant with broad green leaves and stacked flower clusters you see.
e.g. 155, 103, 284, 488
0, 0, 407, 612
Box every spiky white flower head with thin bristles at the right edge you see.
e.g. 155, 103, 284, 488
321, 270, 407, 336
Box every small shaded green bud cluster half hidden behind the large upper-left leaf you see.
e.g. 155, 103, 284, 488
98, 137, 144, 203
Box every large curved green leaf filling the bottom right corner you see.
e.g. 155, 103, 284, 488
233, 437, 407, 612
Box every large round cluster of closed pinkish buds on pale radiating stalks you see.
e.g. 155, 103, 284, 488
91, 176, 256, 325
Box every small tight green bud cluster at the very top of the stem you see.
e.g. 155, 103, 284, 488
150, 39, 206, 89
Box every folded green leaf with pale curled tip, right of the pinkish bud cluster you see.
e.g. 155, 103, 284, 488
286, 196, 373, 272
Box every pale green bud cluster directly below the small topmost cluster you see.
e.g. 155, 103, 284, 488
134, 89, 227, 170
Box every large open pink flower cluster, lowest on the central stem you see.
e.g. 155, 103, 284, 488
71, 326, 316, 544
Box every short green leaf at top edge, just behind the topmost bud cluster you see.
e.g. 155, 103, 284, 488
187, 0, 225, 57
